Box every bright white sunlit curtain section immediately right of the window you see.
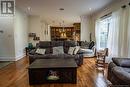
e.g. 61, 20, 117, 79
107, 10, 121, 58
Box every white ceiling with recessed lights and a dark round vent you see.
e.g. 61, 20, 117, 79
16, 0, 119, 26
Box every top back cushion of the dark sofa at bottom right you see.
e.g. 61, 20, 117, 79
112, 58, 130, 67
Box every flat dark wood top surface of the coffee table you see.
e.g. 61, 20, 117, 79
29, 59, 77, 69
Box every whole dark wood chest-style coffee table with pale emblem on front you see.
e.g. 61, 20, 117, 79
28, 59, 77, 85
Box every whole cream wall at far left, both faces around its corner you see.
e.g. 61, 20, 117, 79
0, 9, 28, 61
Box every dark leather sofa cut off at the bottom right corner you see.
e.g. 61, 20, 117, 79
108, 58, 130, 86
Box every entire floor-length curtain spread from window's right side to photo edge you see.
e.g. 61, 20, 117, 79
108, 6, 130, 57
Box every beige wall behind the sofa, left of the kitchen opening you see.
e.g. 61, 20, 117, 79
29, 16, 51, 46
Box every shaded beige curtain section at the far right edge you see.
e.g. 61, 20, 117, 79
118, 8, 128, 57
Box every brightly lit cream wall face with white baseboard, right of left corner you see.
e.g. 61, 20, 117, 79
14, 9, 28, 60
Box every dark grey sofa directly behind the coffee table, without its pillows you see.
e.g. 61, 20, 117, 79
29, 41, 83, 66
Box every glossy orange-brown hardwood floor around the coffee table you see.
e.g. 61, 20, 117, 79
0, 57, 107, 87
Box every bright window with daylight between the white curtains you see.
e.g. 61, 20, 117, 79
99, 17, 111, 48
